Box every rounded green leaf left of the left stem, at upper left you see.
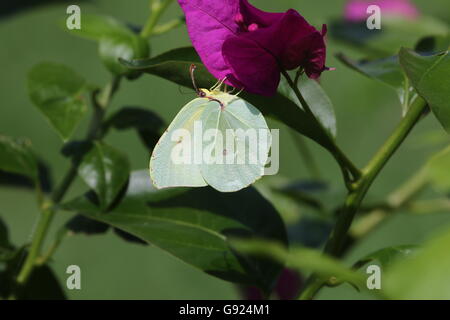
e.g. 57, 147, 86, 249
28, 62, 87, 140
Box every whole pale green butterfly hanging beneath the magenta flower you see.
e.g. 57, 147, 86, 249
150, 65, 272, 192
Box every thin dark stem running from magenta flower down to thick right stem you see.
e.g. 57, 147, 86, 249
281, 68, 361, 186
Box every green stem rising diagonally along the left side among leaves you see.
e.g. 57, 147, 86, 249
16, 77, 120, 285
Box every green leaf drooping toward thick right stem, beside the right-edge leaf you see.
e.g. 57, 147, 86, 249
337, 54, 412, 114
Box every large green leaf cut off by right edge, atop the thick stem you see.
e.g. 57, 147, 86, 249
400, 48, 450, 133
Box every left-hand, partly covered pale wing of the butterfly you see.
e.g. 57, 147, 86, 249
150, 98, 210, 189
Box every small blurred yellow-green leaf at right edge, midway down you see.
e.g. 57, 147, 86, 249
425, 146, 450, 194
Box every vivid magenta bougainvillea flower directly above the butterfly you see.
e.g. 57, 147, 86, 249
178, 0, 326, 95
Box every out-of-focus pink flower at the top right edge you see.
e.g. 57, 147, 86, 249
345, 0, 419, 22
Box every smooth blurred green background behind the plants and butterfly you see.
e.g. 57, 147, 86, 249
0, 0, 450, 299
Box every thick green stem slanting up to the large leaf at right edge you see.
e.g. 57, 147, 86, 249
300, 98, 426, 300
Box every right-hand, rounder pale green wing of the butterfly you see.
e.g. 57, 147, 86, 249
200, 94, 271, 192
